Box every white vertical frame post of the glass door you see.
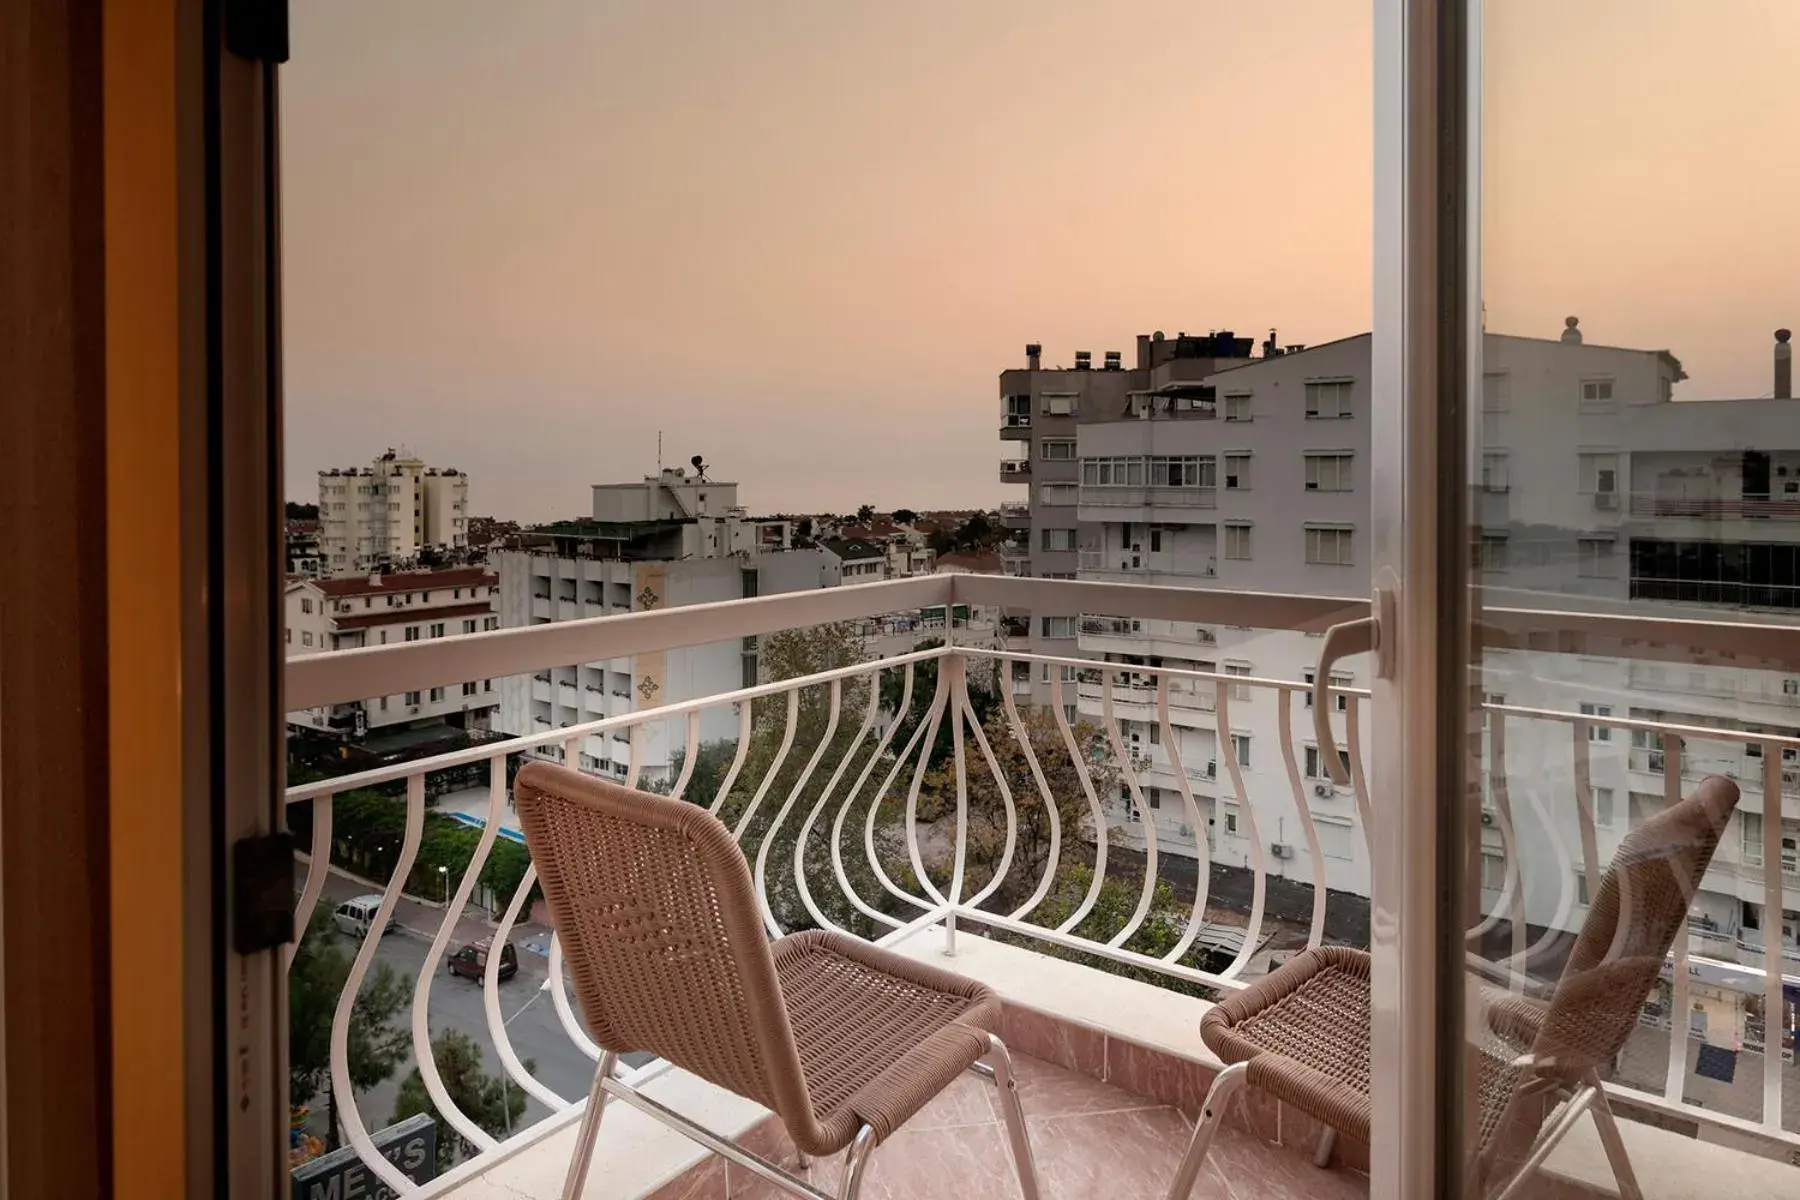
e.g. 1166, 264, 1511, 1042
1368, 0, 1480, 1200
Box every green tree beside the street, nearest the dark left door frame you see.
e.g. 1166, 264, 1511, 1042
288, 909, 412, 1150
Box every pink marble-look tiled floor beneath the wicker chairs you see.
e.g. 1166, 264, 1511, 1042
648, 1054, 1368, 1200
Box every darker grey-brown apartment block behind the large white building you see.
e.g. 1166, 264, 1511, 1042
999, 331, 1251, 703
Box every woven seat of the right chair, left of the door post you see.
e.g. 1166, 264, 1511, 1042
1201, 946, 1370, 1141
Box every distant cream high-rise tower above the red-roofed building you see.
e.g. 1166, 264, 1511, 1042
319, 450, 468, 578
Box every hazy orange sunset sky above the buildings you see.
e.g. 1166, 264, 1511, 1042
281, 0, 1800, 520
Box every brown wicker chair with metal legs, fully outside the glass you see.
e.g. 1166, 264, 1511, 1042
513, 763, 1039, 1200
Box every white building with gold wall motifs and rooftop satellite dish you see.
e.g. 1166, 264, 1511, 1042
491, 468, 841, 783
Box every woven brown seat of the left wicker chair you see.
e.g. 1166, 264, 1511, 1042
770, 930, 1001, 1155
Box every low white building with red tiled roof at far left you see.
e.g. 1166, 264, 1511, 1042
284, 567, 500, 739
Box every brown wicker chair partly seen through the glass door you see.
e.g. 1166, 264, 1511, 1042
1168, 775, 1737, 1200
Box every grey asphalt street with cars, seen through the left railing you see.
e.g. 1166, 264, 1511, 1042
302, 874, 650, 1137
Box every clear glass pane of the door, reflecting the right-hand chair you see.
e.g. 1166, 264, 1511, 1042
1449, 2, 1800, 1196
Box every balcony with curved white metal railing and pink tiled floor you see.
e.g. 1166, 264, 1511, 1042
286, 576, 1787, 1200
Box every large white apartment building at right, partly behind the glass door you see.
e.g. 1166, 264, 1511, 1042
1003, 324, 1800, 968
